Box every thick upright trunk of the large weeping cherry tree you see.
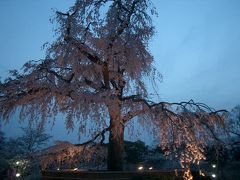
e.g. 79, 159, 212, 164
108, 104, 124, 171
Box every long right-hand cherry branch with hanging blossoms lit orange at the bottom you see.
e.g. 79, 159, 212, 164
121, 98, 227, 176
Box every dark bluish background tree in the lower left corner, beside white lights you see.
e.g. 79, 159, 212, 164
0, 127, 51, 179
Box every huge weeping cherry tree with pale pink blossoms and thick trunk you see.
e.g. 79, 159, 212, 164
0, 0, 227, 175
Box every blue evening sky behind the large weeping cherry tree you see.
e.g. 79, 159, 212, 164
0, 0, 240, 145
